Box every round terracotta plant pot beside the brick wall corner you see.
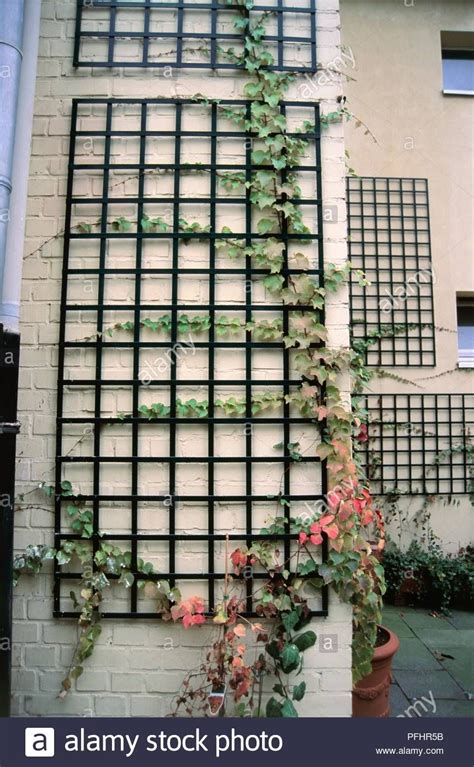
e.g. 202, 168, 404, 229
352, 626, 400, 717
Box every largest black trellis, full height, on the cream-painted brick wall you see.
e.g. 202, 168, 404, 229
55, 99, 328, 618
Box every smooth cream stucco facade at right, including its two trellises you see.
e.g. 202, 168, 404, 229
341, 0, 474, 553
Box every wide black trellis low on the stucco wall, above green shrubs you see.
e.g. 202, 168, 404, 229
358, 394, 474, 495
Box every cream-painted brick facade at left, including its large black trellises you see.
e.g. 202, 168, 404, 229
9, 0, 351, 716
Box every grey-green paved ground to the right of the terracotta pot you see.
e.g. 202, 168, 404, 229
383, 606, 474, 718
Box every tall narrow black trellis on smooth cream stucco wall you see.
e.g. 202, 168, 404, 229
347, 177, 436, 367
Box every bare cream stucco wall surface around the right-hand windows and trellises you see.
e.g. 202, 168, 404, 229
341, 0, 474, 552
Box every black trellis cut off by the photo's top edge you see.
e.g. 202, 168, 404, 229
73, 0, 317, 72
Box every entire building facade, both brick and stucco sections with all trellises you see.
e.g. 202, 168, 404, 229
5, 0, 474, 716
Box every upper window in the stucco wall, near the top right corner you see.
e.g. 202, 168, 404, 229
441, 32, 474, 96
